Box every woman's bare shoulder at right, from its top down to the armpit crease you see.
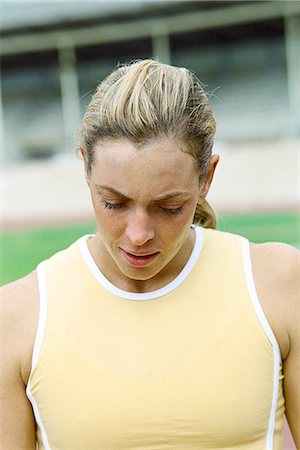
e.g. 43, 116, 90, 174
251, 242, 300, 358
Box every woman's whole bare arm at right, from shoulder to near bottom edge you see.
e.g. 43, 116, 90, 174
251, 243, 300, 448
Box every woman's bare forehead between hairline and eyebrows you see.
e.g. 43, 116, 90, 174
91, 138, 199, 199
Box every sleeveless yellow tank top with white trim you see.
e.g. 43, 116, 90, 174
27, 227, 284, 450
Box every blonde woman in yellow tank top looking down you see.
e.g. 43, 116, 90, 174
3, 60, 300, 450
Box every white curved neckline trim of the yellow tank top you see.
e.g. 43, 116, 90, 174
77, 226, 203, 300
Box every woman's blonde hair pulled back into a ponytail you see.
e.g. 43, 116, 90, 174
79, 59, 216, 228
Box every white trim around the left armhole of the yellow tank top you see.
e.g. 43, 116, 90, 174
28, 263, 47, 386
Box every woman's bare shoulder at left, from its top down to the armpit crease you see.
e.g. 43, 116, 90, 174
1, 272, 39, 384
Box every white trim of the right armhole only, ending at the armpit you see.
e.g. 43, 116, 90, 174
242, 237, 281, 362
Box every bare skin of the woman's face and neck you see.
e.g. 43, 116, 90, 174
87, 138, 217, 292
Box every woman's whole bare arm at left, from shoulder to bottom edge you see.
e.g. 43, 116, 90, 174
0, 274, 38, 450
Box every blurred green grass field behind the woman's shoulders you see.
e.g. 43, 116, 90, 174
0, 214, 300, 285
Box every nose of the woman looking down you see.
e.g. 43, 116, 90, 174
126, 209, 155, 247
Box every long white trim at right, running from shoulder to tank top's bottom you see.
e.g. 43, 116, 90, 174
242, 238, 281, 450
